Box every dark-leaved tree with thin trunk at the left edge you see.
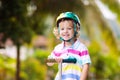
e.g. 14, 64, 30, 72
0, 0, 44, 80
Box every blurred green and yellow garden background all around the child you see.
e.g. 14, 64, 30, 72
0, 0, 120, 80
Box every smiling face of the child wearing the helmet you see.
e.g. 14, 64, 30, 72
59, 20, 74, 40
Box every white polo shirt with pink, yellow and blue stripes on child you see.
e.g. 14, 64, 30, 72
49, 40, 91, 80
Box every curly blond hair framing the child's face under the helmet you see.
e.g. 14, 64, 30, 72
53, 18, 80, 39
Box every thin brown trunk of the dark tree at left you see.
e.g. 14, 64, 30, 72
16, 43, 20, 80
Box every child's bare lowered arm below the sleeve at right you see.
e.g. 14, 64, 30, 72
80, 64, 89, 80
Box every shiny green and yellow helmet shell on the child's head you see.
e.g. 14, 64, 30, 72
56, 12, 80, 26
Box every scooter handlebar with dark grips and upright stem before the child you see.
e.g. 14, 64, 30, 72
46, 58, 77, 80
